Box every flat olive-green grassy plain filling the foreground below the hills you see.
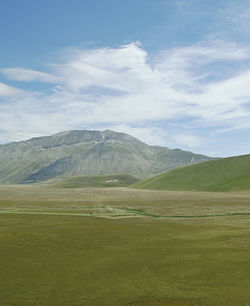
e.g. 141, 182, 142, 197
0, 185, 250, 306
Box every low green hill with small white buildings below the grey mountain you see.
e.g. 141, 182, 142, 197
53, 174, 138, 188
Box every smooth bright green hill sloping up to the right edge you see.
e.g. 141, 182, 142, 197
133, 155, 250, 191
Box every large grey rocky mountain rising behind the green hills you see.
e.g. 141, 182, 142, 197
0, 130, 211, 183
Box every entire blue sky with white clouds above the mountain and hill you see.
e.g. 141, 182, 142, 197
0, 0, 250, 157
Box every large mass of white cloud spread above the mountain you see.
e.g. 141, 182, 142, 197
0, 41, 250, 151
